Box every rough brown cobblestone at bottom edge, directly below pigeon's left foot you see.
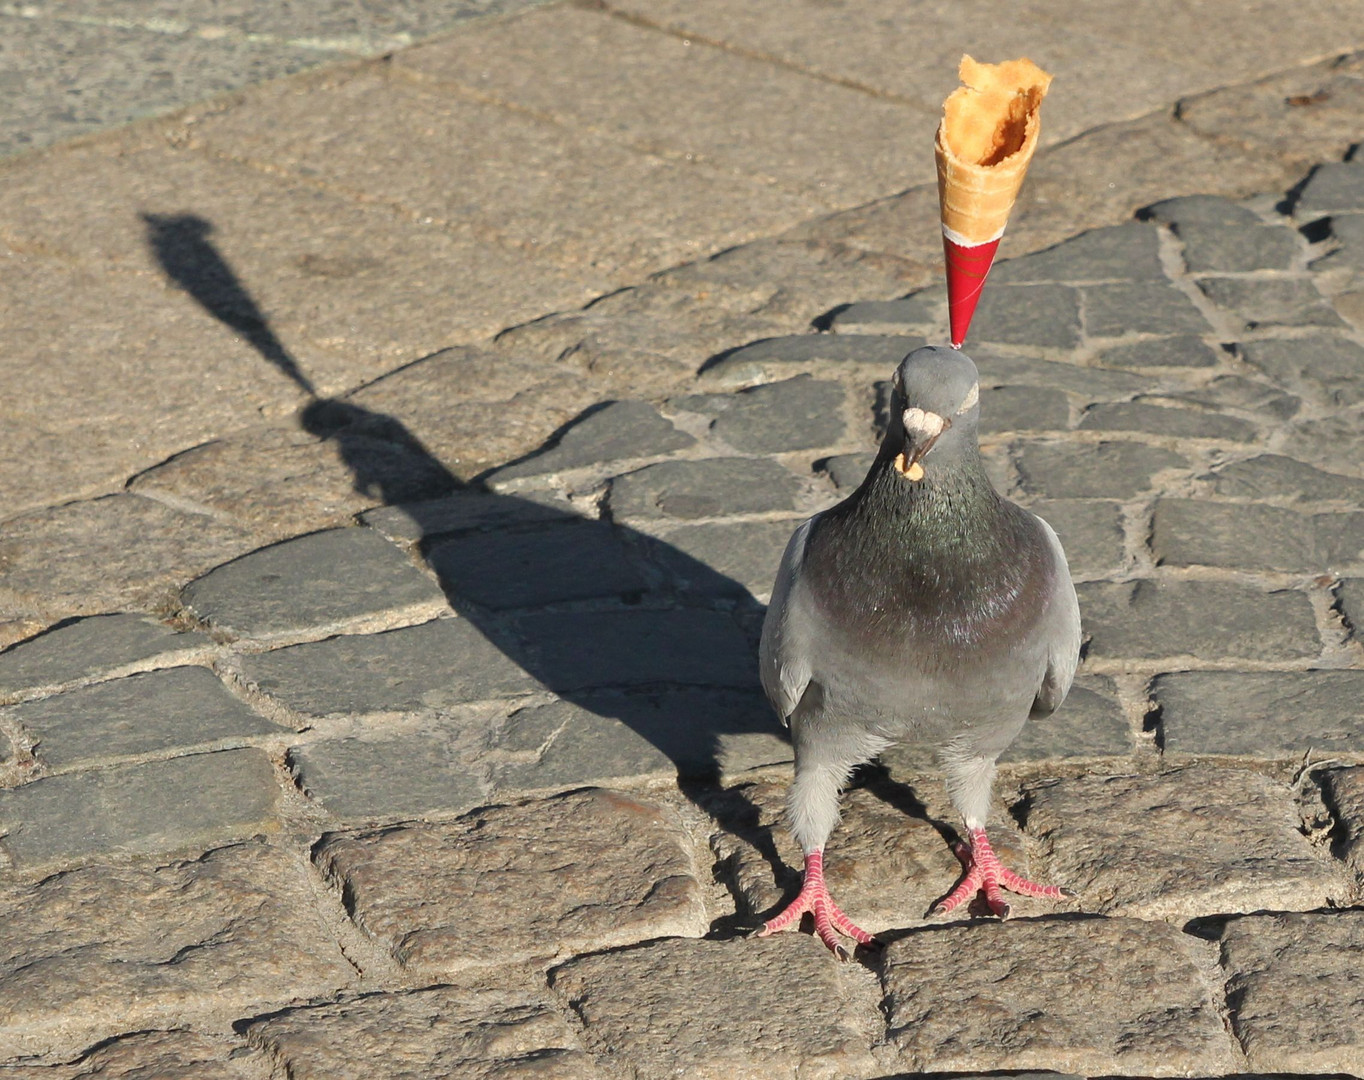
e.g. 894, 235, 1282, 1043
550, 934, 881, 1080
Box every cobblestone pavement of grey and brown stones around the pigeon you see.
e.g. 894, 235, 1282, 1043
0, 4, 1364, 1080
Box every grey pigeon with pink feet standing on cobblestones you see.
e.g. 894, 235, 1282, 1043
758, 346, 1080, 959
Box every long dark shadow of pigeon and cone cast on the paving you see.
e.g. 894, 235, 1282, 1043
142, 214, 784, 927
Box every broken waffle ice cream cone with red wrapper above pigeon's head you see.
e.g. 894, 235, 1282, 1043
933, 56, 1052, 348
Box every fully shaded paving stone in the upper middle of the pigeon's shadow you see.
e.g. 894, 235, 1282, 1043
427, 521, 648, 611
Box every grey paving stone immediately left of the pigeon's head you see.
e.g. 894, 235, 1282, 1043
668, 376, 846, 454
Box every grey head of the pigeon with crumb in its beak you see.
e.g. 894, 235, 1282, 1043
887, 345, 981, 480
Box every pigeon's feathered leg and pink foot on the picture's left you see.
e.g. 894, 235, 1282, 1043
758, 766, 876, 960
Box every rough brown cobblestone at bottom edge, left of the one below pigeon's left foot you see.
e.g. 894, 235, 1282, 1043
246, 972, 602, 1080
